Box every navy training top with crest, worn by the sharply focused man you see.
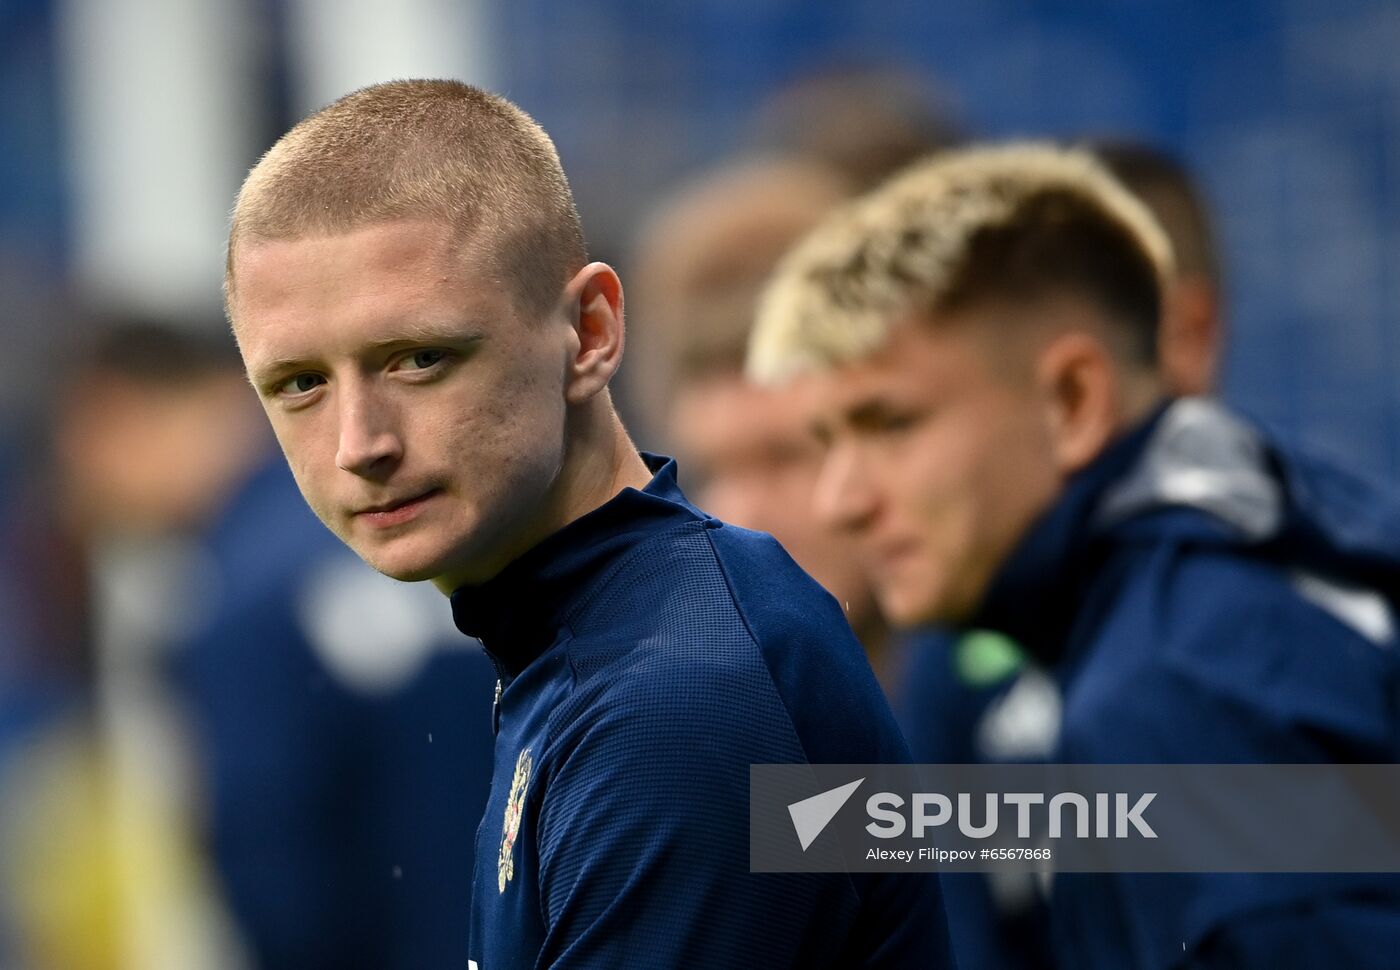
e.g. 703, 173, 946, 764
452, 455, 951, 970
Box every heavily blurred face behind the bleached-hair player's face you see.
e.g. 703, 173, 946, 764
671, 374, 874, 627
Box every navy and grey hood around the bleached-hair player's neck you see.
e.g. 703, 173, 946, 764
973, 398, 1344, 662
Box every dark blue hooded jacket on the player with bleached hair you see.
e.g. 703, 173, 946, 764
977, 399, 1400, 970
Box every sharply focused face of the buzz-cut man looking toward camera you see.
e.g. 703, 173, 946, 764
234, 220, 571, 589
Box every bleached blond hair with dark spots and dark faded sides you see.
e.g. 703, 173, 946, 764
748, 143, 1172, 384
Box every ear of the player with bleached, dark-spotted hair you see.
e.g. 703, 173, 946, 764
1035, 330, 1123, 475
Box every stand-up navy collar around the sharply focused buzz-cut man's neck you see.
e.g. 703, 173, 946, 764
452, 452, 706, 675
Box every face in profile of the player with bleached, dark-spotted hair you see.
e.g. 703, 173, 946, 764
799, 312, 1061, 624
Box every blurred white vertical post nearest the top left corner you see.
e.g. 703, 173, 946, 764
59, 0, 259, 318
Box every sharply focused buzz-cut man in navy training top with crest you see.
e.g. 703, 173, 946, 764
227, 81, 948, 970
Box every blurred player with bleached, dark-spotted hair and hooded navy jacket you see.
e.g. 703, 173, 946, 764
749, 146, 1400, 967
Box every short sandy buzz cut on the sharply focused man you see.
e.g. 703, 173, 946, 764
224, 80, 587, 316
